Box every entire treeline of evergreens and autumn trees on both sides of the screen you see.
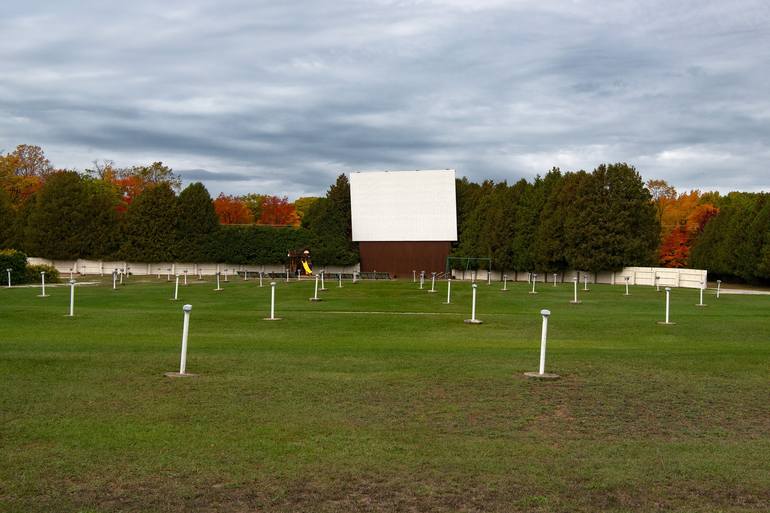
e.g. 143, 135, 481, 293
0, 145, 770, 282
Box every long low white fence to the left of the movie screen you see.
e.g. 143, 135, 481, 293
27, 257, 360, 276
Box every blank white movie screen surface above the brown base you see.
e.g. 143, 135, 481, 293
350, 170, 457, 242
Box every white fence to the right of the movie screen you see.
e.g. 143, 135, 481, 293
452, 267, 708, 289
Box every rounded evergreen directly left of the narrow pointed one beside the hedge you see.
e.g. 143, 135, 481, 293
120, 183, 177, 262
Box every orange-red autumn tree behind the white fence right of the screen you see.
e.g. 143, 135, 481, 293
647, 180, 719, 267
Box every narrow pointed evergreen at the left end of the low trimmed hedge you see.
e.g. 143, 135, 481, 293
175, 182, 219, 262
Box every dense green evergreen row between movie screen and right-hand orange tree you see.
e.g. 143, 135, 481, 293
453, 163, 660, 272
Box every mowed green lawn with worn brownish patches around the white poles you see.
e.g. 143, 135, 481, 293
0, 278, 770, 512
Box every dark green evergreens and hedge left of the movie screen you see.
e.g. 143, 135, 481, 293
0, 171, 358, 265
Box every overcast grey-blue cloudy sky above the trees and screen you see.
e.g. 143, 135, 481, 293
0, 0, 770, 199
